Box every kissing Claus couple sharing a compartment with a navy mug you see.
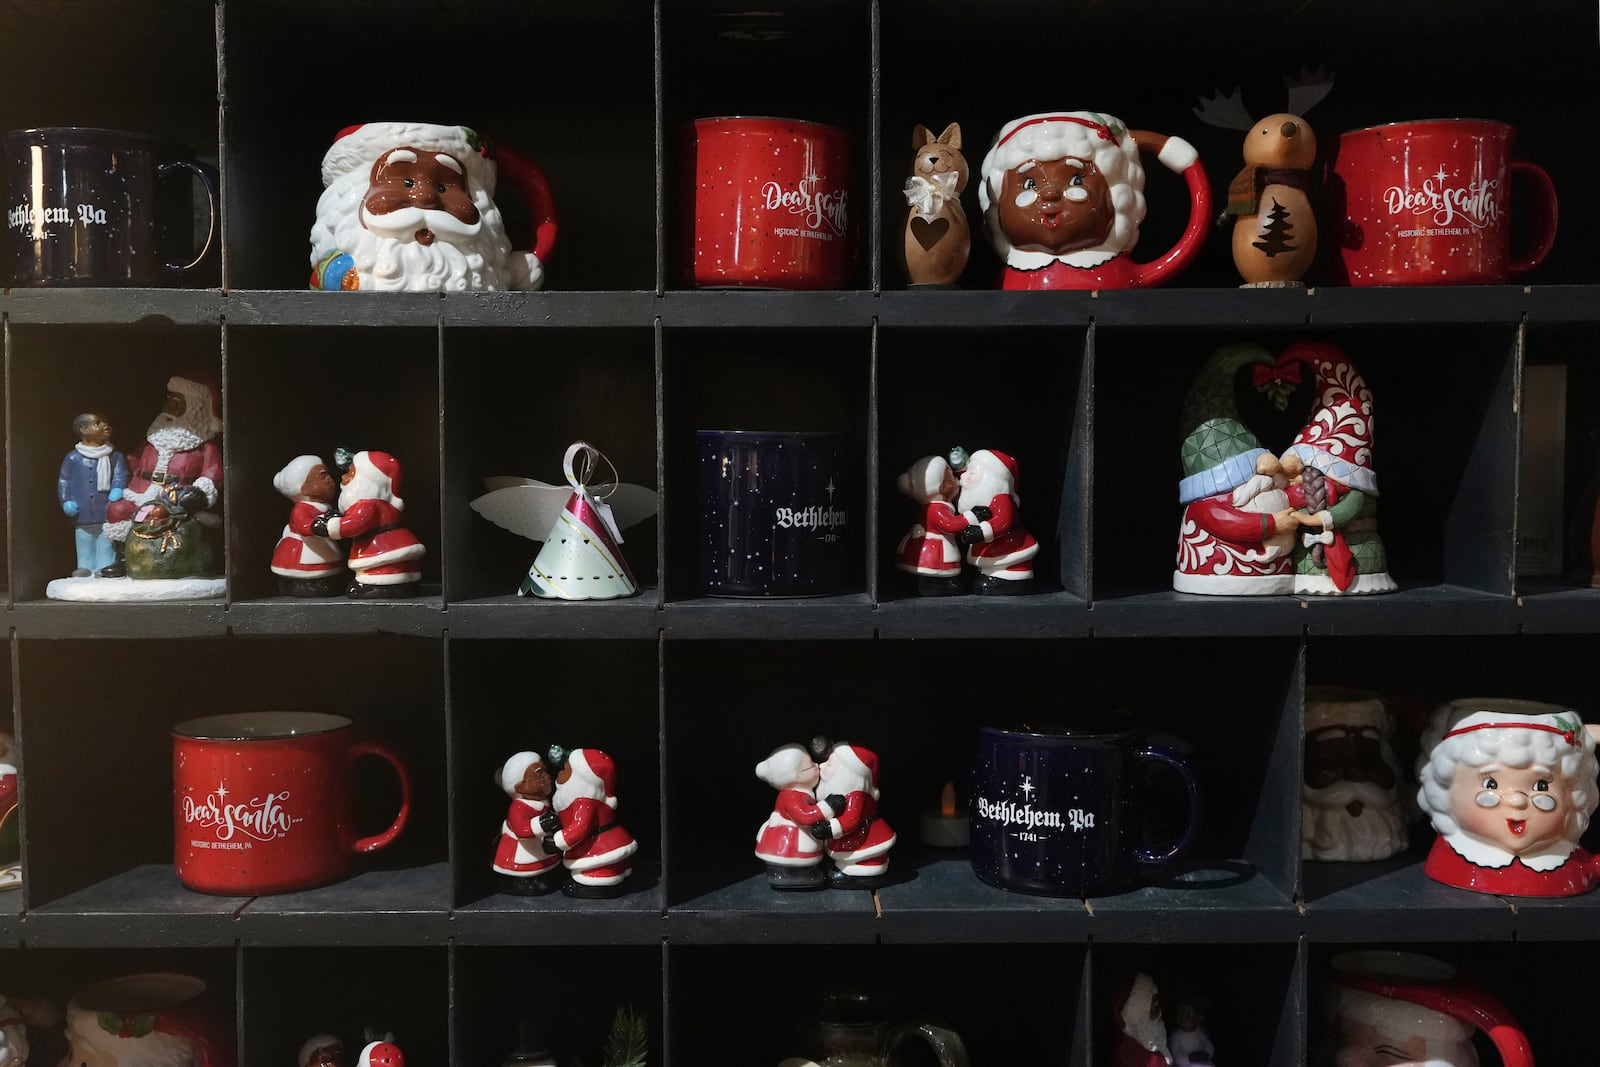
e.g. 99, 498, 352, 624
755, 737, 896, 889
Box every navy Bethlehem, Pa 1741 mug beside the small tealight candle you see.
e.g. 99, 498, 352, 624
970, 728, 1200, 897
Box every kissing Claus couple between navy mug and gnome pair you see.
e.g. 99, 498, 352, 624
894, 446, 1038, 597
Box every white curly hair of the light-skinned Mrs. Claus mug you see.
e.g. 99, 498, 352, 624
1416, 701, 1600, 841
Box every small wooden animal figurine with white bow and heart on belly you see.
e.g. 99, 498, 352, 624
906, 122, 973, 285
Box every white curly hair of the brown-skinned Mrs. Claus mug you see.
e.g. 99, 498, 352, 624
978, 110, 1146, 270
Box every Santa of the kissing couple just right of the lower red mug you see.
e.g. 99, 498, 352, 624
539, 749, 638, 897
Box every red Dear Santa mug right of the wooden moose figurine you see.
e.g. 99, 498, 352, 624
1328, 118, 1557, 286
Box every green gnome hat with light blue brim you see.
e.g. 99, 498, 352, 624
1178, 344, 1274, 504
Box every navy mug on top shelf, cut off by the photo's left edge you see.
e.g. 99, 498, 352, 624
5, 126, 218, 286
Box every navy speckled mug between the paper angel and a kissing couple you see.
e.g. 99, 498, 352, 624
698, 430, 858, 597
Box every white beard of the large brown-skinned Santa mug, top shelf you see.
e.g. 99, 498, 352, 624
312, 171, 524, 293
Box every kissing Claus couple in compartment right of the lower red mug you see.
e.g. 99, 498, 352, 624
493, 745, 638, 897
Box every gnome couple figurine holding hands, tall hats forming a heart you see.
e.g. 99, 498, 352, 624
1173, 341, 1395, 597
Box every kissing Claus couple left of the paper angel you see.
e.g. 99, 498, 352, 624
272, 450, 427, 600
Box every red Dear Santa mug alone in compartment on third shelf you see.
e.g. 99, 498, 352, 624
173, 712, 411, 896
